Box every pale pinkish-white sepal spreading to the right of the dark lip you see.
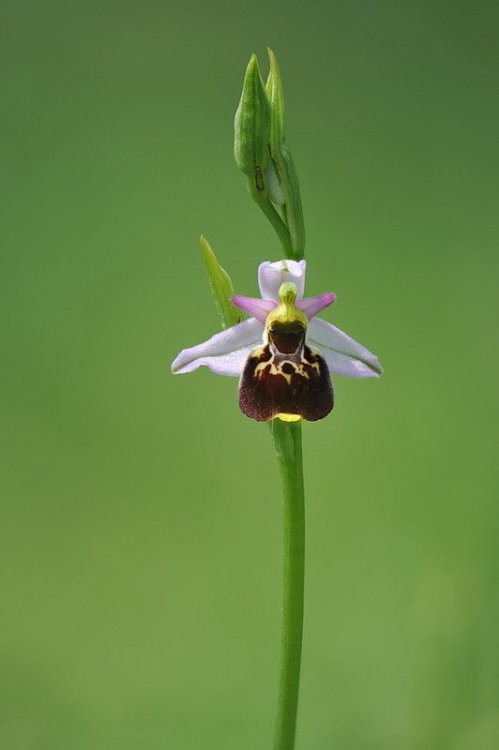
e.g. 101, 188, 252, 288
307, 318, 383, 378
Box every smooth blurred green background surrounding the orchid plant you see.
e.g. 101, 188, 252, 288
0, 0, 499, 750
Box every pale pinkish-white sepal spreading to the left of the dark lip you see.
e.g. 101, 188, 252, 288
172, 318, 263, 376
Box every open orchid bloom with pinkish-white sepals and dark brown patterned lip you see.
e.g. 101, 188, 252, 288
172, 260, 383, 422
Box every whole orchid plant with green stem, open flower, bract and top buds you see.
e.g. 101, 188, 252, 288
172, 49, 383, 750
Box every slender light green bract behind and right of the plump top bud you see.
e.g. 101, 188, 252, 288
266, 49, 305, 257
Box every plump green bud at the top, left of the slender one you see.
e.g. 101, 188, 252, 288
234, 55, 271, 194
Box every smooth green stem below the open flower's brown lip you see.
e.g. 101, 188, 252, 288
272, 419, 305, 750
